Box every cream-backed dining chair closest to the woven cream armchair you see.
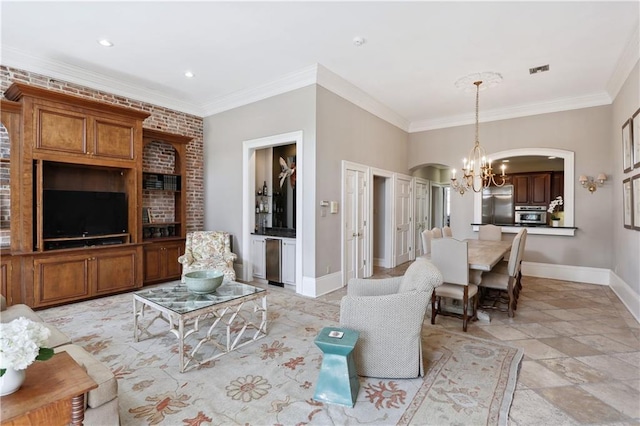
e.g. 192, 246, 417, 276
431, 238, 478, 331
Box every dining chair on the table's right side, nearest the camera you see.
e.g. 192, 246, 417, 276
480, 228, 527, 318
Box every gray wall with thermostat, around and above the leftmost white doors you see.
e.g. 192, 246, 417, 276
315, 86, 408, 276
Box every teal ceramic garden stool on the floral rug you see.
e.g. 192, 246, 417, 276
313, 327, 360, 407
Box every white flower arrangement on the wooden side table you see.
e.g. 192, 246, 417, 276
0, 317, 53, 377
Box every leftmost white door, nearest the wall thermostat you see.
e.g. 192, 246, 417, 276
344, 169, 366, 283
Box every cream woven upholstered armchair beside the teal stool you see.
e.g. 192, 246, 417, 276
340, 258, 442, 379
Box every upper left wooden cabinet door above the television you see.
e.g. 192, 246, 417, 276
35, 105, 89, 155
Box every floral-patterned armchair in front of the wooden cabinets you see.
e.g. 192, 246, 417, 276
178, 231, 238, 282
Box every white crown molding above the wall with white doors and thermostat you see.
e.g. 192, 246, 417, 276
317, 64, 410, 132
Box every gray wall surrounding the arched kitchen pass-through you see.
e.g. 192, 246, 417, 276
409, 105, 622, 269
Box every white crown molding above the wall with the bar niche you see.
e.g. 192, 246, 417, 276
203, 64, 318, 116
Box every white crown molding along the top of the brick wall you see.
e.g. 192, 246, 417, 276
2, 46, 203, 117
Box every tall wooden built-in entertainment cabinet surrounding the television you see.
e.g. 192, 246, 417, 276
2, 83, 152, 308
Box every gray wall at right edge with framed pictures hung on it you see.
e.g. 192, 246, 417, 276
608, 62, 640, 294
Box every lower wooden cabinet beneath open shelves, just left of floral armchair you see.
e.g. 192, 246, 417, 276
144, 239, 185, 284
